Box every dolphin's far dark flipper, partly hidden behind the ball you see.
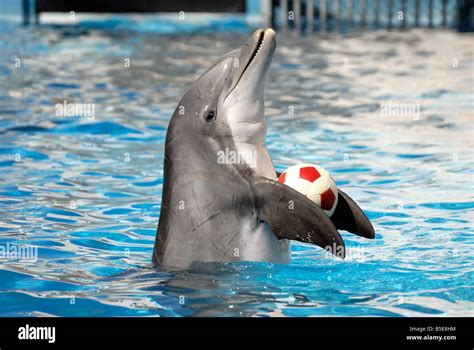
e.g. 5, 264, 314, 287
331, 189, 375, 239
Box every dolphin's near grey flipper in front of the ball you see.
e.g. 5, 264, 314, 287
253, 177, 345, 258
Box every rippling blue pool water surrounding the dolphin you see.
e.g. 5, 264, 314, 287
0, 23, 474, 316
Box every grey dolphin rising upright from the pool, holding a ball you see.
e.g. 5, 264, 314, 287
153, 29, 375, 268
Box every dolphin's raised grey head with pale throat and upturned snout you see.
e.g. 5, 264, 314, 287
168, 29, 276, 161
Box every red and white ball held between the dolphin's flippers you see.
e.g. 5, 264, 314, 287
278, 164, 337, 216
